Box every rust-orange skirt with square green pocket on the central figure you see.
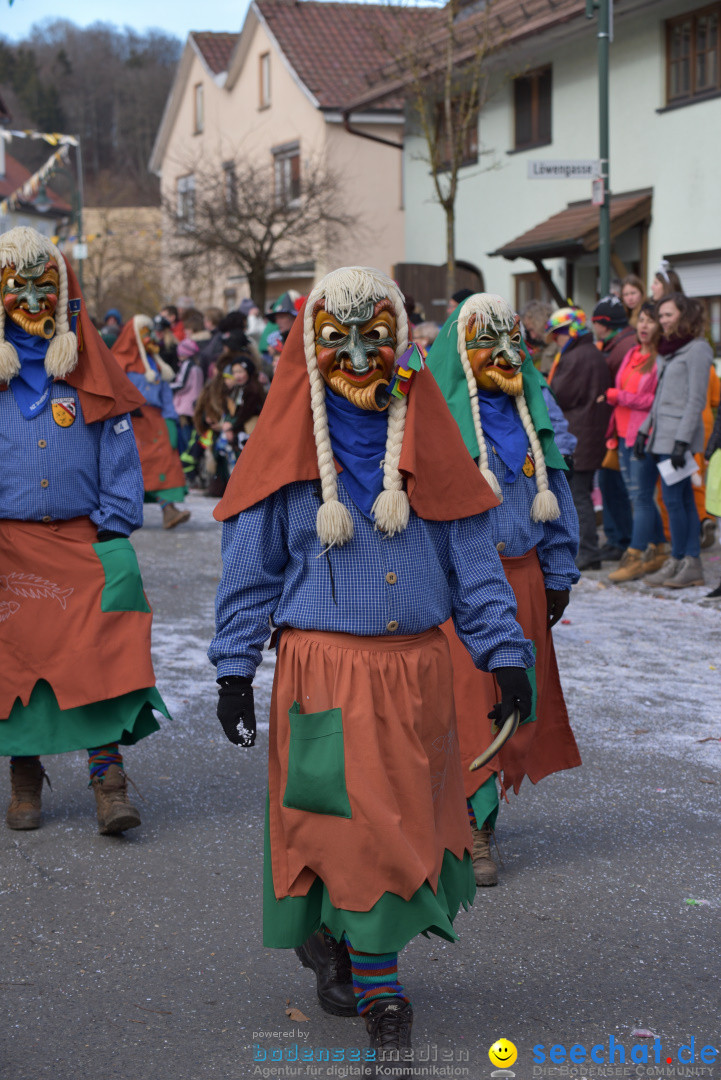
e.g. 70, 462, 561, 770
262, 627, 473, 947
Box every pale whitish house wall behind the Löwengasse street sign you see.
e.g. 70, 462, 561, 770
405, 2, 721, 313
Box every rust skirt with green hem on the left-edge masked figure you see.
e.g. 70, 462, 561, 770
0, 517, 165, 754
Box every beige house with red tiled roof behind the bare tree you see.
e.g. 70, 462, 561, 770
150, 0, 418, 309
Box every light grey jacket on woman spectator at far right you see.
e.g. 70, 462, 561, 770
638, 338, 713, 454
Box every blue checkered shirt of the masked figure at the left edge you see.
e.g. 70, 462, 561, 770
0, 379, 142, 536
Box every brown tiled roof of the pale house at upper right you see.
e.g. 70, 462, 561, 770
353, 0, 591, 108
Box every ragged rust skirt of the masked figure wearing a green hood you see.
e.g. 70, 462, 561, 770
441, 548, 581, 798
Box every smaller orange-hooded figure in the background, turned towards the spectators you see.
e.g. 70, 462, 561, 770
112, 315, 190, 529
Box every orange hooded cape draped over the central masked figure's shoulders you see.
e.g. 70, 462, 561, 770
214, 305, 499, 522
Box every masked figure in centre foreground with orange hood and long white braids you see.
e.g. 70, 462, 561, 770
209, 267, 533, 1049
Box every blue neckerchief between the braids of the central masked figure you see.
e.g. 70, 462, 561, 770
326, 389, 387, 521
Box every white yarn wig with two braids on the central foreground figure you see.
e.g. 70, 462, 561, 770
303, 267, 410, 548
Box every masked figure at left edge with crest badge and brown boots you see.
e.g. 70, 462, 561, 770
0, 228, 167, 834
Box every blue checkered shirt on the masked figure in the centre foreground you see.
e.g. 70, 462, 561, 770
208, 481, 533, 677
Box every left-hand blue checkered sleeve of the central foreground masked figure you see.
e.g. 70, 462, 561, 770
208, 492, 288, 678
